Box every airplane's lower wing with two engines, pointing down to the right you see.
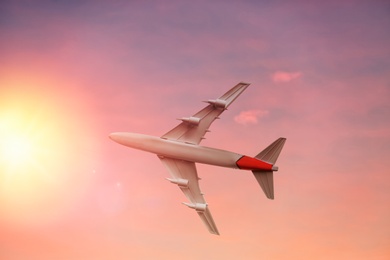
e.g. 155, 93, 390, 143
159, 156, 219, 235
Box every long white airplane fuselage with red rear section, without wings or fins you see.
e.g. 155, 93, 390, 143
110, 133, 276, 170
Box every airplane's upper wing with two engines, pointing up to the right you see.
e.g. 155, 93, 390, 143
161, 82, 249, 144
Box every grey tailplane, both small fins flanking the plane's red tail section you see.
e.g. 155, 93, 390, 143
252, 138, 286, 199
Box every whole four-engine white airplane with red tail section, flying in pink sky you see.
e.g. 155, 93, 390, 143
109, 82, 286, 235
